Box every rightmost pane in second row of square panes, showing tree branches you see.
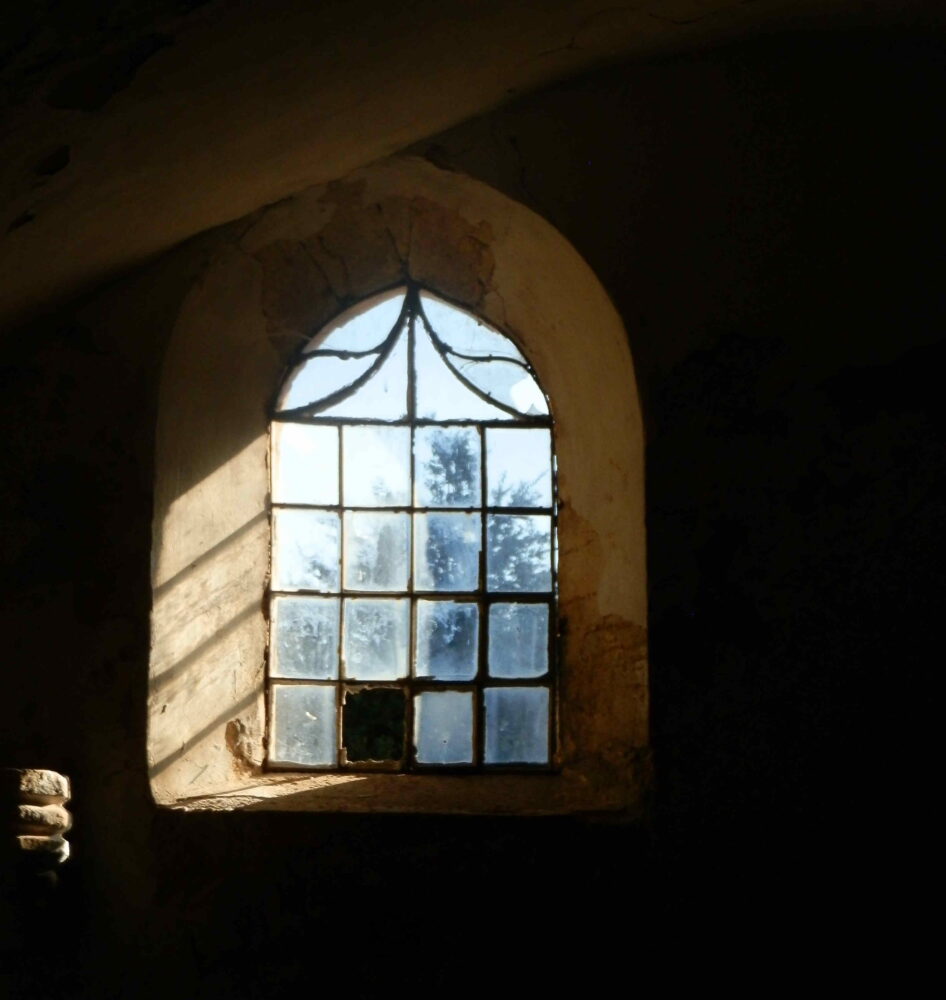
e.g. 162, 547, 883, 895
486, 514, 552, 593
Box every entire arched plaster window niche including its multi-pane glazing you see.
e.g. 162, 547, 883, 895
148, 157, 649, 818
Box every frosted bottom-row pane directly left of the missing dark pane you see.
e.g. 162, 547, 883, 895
270, 684, 337, 767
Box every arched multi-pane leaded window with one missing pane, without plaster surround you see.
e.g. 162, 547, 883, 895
268, 285, 556, 771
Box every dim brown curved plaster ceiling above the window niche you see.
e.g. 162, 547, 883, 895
0, 0, 937, 322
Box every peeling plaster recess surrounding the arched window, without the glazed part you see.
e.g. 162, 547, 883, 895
147, 157, 651, 818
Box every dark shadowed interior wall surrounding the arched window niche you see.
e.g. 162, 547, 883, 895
0, 32, 946, 998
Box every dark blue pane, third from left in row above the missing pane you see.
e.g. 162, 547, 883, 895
414, 601, 479, 681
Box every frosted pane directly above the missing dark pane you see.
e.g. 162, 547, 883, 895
343, 597, 410, 681
